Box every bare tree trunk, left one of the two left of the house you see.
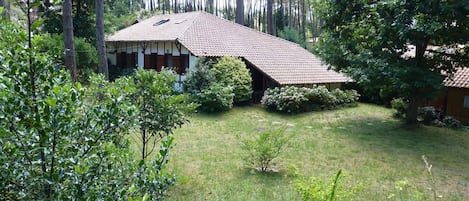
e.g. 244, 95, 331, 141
62, 0, 77, 82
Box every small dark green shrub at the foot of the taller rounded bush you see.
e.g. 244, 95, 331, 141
193, 83, 234, 112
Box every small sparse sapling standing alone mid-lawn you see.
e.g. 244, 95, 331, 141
241, 128, 291, 172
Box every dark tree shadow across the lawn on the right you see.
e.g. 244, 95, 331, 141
332, 117, 469, 164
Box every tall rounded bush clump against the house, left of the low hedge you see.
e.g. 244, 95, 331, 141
184, 57, 252, 112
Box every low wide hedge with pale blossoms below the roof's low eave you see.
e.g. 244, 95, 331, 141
261, 86, 359, 113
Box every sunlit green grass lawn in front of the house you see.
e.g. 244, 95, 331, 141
131, 104, 469, 200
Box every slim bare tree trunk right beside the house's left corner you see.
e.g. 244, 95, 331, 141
96, 0, 109, 80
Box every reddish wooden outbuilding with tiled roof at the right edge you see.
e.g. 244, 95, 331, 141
444, 68, 469, 124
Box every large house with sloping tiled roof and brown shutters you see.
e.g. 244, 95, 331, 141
106, 12, 350, 98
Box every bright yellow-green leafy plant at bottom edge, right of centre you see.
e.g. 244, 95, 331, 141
292, 170, 360, 201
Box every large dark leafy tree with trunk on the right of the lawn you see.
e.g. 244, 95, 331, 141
317, 0, 469, 124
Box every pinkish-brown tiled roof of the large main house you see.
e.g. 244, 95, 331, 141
108, 12, 351, 85
